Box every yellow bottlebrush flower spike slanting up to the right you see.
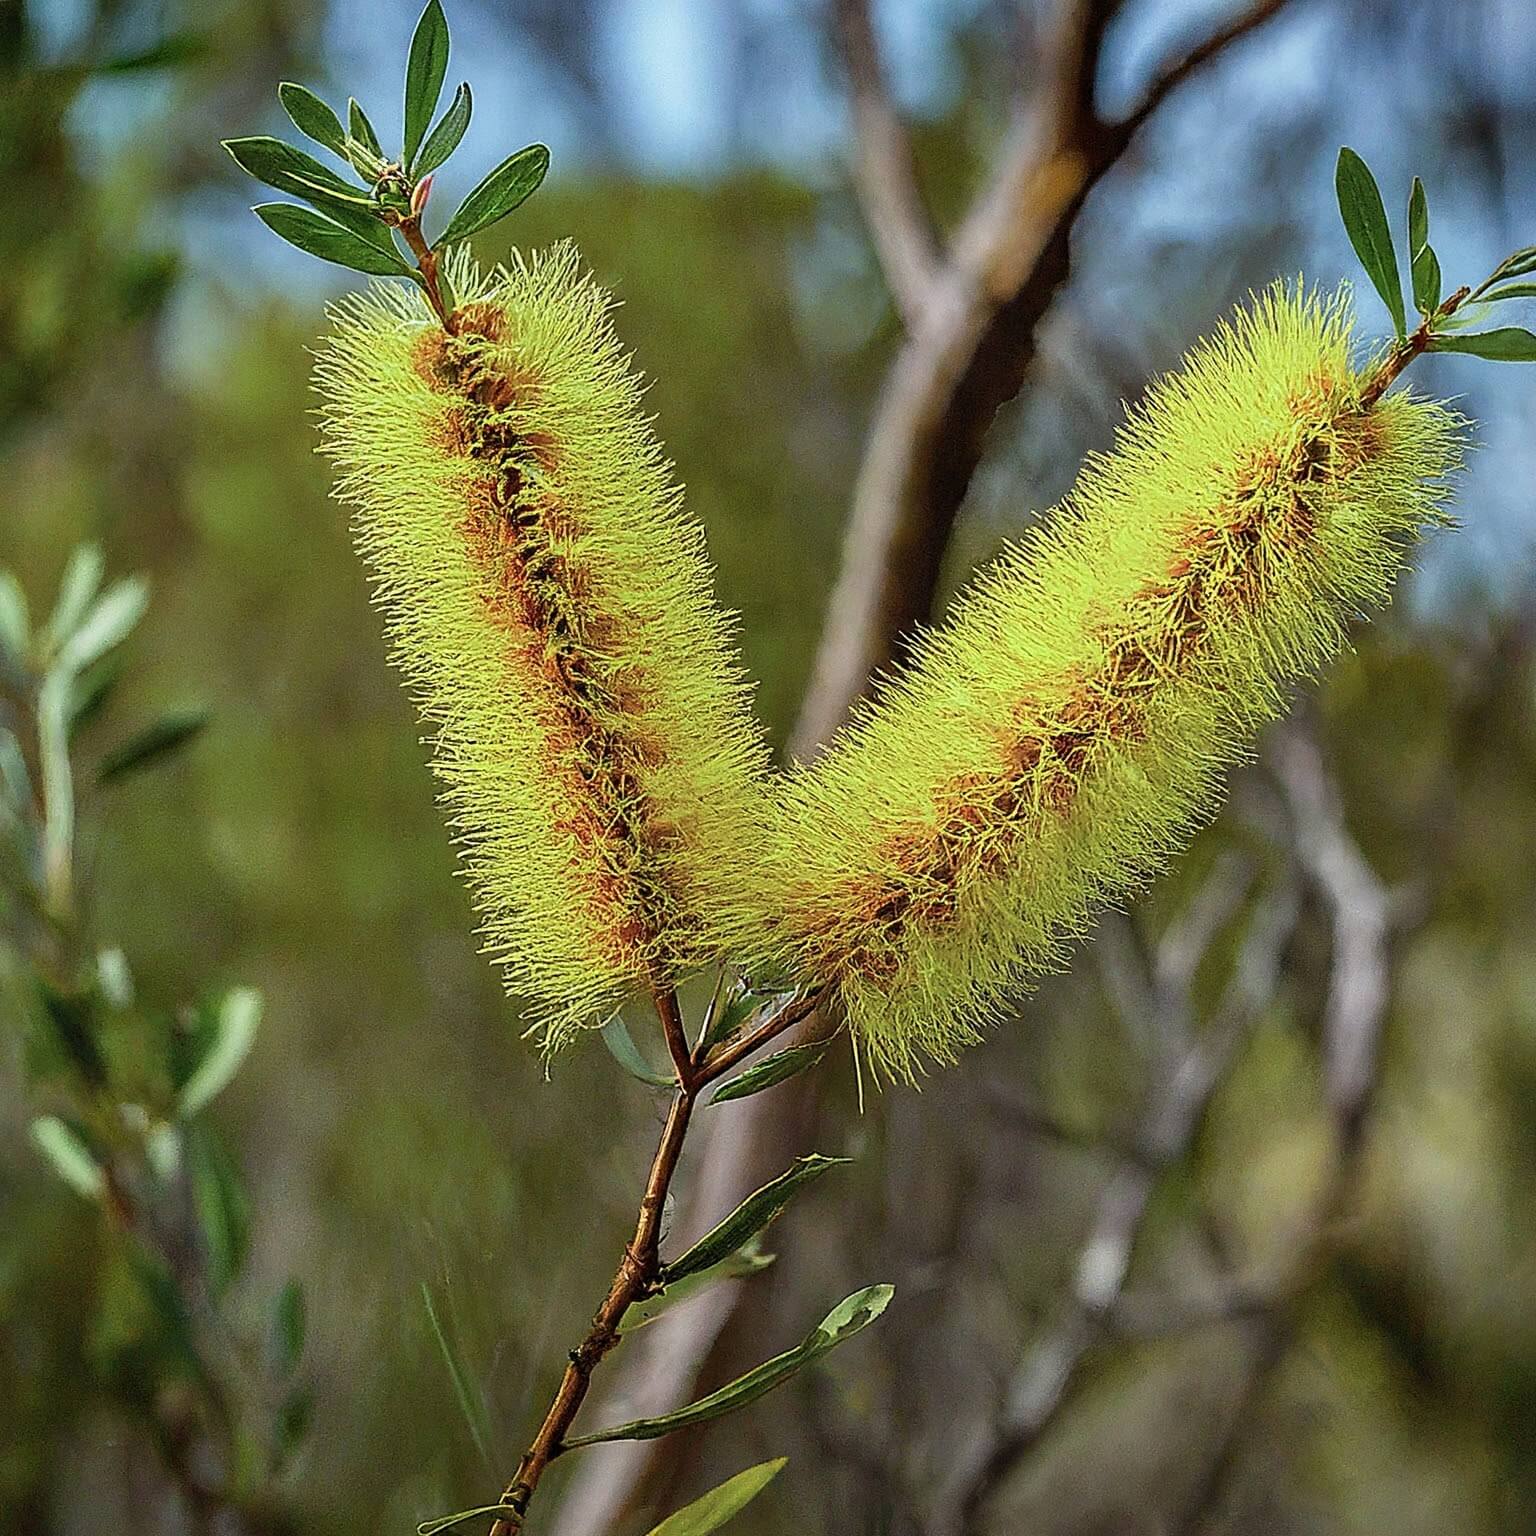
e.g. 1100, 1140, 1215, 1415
751, 287, 1459, 1077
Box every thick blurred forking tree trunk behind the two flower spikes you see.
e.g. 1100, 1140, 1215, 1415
553, 0, 1302, 1536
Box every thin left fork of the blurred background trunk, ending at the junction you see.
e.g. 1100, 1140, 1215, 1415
836, 0, 940, 330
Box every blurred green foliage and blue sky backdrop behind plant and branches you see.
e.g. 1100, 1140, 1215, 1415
9, 0, 1536, 1536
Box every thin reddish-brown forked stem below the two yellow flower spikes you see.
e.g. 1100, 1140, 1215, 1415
490, 988, 819, 1536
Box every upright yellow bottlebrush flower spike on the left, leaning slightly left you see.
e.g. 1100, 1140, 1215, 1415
316, 246, 766, 1048
